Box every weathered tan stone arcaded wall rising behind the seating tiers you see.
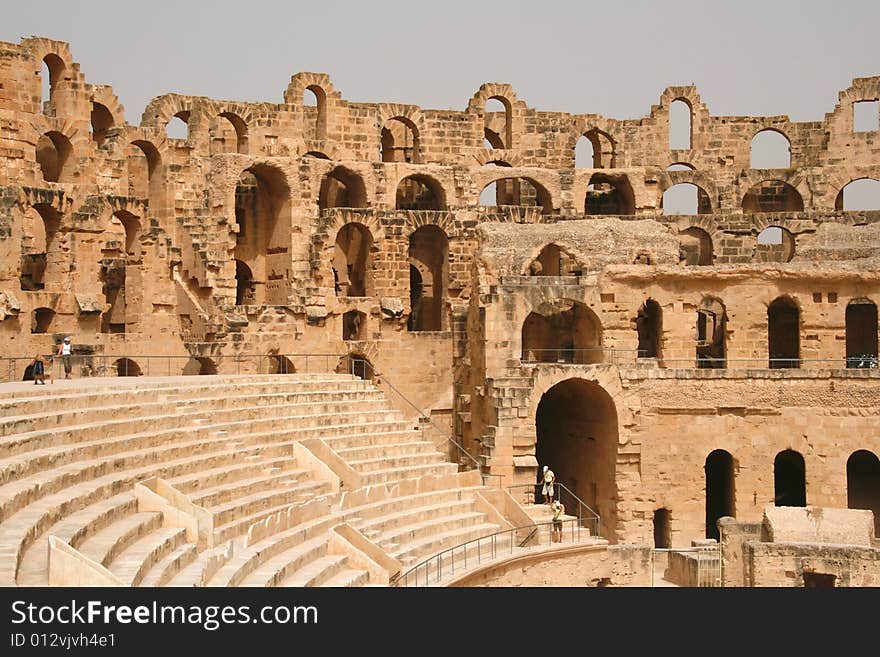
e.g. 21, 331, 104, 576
0, 38, 880, 545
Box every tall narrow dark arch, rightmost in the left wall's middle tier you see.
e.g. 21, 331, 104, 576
407, 226, 449, 331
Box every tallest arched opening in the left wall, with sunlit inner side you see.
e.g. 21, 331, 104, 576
235, 165, 291, 305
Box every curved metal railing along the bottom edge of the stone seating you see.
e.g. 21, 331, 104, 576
390, 518, 589, 587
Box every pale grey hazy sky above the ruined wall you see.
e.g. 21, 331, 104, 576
0, 0, 880, 124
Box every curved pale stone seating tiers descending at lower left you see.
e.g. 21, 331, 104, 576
0, 374, 528, 587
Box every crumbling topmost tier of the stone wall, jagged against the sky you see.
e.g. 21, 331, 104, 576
0, 38, 880, 177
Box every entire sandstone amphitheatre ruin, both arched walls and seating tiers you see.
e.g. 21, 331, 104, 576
0, 37, 880, 587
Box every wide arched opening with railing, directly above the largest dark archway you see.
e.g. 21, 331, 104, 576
522, 300, 602, 364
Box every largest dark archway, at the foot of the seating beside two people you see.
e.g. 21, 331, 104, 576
535, 378, 618, 540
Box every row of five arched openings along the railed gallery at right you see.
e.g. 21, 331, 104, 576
520, 296, 878, 369
